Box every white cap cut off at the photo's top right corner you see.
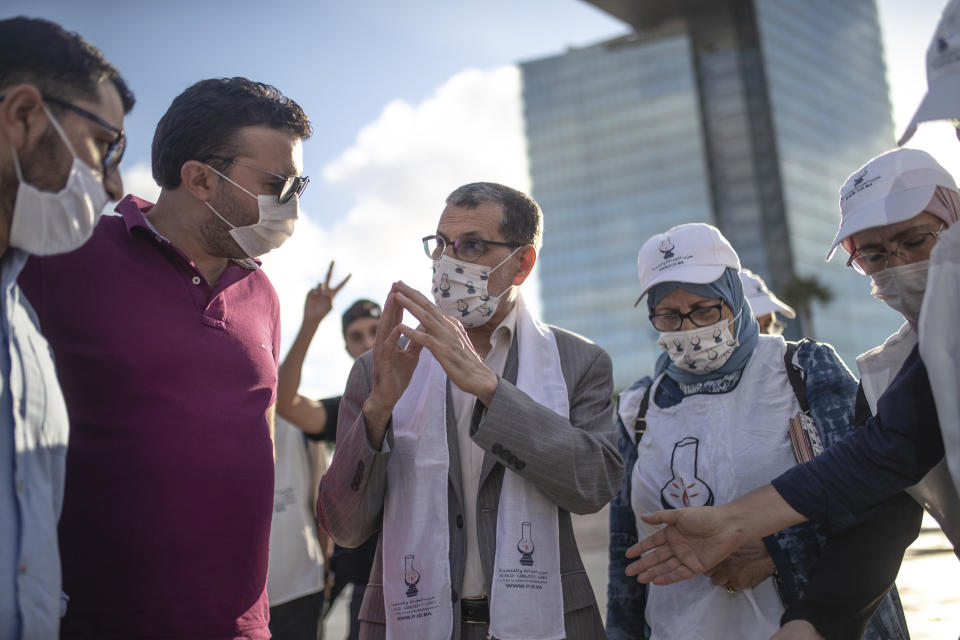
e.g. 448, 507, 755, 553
897, 0, 960, 146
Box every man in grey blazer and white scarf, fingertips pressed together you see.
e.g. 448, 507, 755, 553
318, 182, 623, 640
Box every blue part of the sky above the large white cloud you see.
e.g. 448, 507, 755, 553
2, 0, 626, 216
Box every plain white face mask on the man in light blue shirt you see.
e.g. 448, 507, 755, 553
10, 105, 110, 256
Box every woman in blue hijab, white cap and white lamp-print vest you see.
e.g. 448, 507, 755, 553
607, 224, 907, 640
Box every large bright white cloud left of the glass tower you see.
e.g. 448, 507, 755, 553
264, 66, 539, 396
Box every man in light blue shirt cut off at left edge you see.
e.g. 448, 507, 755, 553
0, 18, 134, 639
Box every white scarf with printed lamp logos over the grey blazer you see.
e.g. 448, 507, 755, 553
383, 298, 569, 640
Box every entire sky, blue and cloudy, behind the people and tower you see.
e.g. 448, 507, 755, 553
0, 0, 960, 395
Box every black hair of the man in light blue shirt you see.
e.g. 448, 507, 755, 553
0, 16, 135, 113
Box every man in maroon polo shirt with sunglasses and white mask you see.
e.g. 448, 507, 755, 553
21, 78, 311, 640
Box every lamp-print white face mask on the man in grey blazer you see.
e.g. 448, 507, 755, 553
433, 247, 522, 329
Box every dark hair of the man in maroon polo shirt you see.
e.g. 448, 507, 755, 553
153, 77, 313, 189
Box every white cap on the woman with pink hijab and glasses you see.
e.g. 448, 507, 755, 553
827, 149, 957, 260
